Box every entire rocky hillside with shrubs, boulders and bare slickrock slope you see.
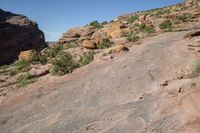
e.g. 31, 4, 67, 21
0, 0, 200, 133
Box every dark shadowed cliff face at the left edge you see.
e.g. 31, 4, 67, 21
0, 9, 45, 65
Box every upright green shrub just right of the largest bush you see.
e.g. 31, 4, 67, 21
80, 51, 94, 66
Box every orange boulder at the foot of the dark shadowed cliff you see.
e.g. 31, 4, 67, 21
18, 50, 36, 61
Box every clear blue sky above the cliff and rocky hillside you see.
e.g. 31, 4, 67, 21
0, 0, 182, 41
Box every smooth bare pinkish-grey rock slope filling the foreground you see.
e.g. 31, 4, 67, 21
0, 31, 200, 133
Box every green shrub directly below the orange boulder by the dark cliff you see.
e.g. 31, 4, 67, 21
15, 60, 31, 72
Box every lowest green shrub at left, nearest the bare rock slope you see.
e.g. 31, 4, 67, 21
16, 73, 36, 88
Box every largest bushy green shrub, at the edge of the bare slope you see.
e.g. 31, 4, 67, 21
52, 52, 78, 75
